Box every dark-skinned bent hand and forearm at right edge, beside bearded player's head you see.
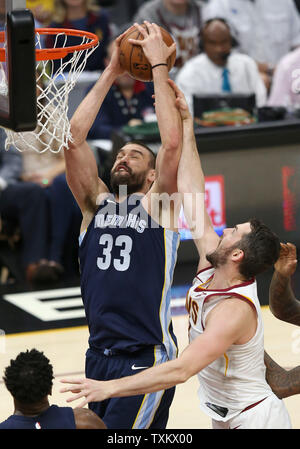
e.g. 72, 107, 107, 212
269, 243, 300, 326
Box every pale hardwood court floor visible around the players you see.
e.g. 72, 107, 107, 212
0, 307, 300, 429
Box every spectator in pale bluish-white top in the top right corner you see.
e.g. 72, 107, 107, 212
204, 0, 300, 88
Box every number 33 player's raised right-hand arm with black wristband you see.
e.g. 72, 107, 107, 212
130, 21, 182, 194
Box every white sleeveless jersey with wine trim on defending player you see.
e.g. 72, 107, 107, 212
186, 267, 274, 421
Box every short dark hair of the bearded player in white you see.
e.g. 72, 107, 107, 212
235, 218, 280, 279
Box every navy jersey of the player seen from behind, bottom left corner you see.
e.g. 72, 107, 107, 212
0, 405, 76, 429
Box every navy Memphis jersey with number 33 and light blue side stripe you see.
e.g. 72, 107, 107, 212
79, 195, 179, 358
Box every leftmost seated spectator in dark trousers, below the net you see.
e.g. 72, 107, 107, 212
0, 129, 56, 282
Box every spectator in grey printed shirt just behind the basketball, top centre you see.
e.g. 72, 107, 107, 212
133, 0, 202, 73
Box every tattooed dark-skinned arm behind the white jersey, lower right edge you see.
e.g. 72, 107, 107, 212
265, 351, 300, 399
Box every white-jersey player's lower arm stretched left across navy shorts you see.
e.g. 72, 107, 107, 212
60, 298, 250, 407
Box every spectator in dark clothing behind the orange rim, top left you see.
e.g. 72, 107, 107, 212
46, 0, 111, 71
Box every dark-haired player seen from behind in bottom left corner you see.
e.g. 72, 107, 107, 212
0, 349, 106, 430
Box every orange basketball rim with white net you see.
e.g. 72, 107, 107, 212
0, 28, 98, 153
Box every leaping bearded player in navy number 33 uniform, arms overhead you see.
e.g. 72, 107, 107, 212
65, 22, 182, 429
